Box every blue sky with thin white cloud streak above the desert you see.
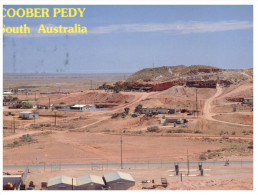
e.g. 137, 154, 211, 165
3, 5, 253, 73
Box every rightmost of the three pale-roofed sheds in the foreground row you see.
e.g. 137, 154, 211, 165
103, 171, 135, 190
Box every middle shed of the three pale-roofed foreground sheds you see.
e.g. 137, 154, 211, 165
75, 175, 105, 190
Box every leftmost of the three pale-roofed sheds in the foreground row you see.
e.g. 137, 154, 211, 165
47, 175, 76, 190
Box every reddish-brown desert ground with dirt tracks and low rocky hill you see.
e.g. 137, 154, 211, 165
3, 66, 253, 190
